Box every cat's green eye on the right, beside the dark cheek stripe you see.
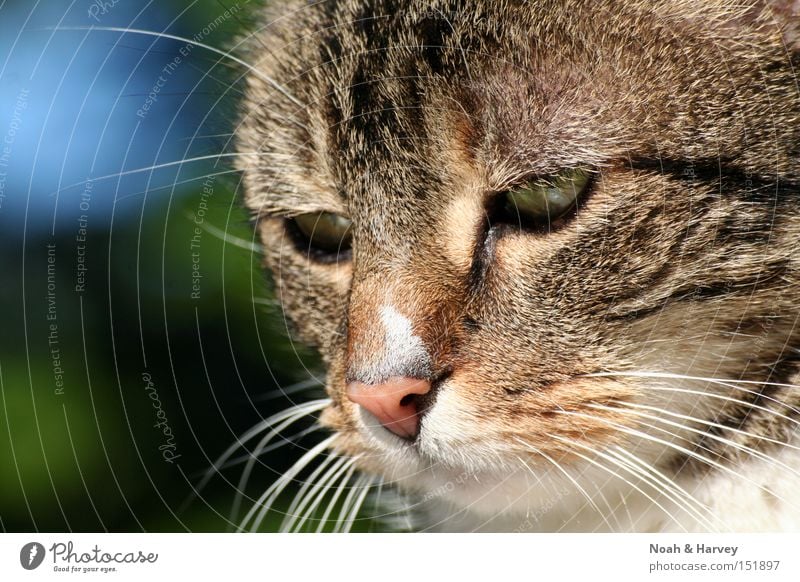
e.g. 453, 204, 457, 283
503, 169, 589, 224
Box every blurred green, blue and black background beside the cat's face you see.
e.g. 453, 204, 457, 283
0, 0, 342, 531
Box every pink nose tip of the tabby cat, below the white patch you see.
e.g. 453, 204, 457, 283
347, 376, 431, 438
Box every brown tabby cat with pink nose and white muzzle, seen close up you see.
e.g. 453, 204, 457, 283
231, 0, 800, 532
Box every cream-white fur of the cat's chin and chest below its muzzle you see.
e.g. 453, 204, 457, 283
376, 438, 800, 532
